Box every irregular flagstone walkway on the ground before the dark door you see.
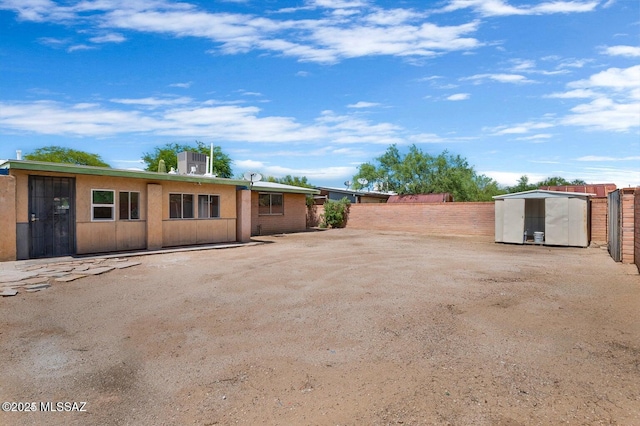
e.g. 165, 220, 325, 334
0, 257, 140, 297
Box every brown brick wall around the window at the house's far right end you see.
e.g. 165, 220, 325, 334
251, 191, 307, 235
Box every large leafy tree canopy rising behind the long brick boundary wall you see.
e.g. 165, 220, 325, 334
353, 144, 504, 201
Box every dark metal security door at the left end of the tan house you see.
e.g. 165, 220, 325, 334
29, 176, 76, 259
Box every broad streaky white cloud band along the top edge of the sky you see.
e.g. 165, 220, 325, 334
0, 0, 481, 63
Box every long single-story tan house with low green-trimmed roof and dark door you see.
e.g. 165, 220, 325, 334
0, 160, 319, 261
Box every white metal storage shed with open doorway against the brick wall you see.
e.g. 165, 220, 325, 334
493, 189, 590, 247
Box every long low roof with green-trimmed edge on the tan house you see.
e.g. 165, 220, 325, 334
0, 160, 320, 194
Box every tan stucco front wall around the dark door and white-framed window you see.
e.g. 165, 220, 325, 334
0, 170, 236, 260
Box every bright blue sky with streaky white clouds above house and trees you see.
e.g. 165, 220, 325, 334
0, 0, 640, 187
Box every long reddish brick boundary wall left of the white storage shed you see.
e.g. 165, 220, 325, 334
347, 202, 495, 237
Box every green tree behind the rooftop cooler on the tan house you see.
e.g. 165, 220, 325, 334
142, 141, 232, 178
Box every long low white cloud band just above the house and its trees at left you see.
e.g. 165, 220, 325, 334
0, 97, 418, 145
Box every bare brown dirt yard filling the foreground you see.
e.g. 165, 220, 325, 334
0, 229, 640, 425
